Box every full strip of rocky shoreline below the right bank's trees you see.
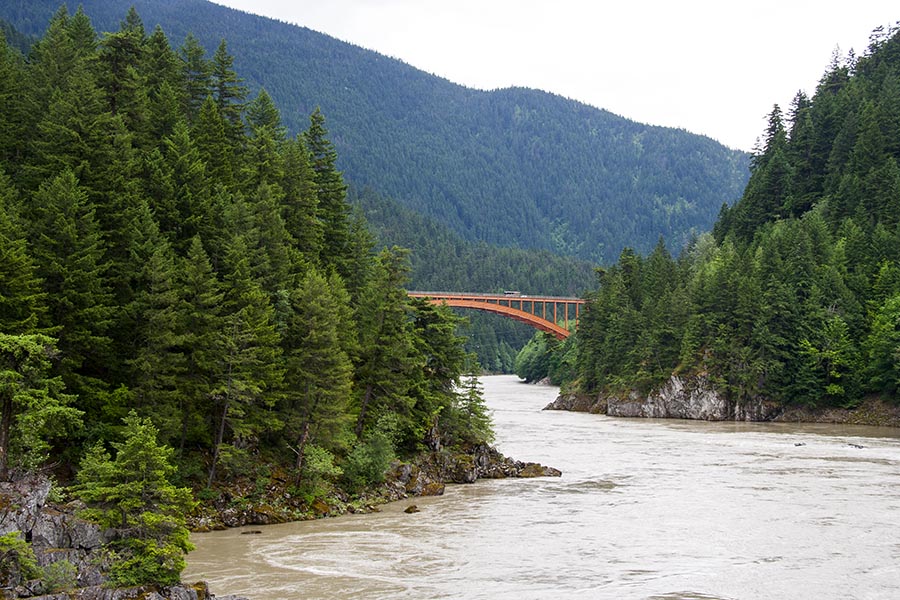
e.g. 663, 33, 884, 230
544, 375, 900, 427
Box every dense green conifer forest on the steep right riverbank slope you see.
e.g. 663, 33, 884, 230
519, 22, 900, 407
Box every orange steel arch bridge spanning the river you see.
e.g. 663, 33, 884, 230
409, 292, 584, 340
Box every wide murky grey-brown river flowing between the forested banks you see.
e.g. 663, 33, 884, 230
183, 376, 900, 600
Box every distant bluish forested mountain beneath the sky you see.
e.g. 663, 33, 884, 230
0, 0, 748, 262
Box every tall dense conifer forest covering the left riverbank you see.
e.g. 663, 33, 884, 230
0, 8, 491, 584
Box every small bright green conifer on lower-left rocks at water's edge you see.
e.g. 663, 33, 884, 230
75, 412, 194, 586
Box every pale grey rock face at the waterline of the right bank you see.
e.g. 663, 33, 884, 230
547, 375, 778, 421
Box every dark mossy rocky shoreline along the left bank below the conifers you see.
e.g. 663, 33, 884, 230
0, 445, 561, 600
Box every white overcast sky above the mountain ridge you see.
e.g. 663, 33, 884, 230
214, 0, 900, 150
